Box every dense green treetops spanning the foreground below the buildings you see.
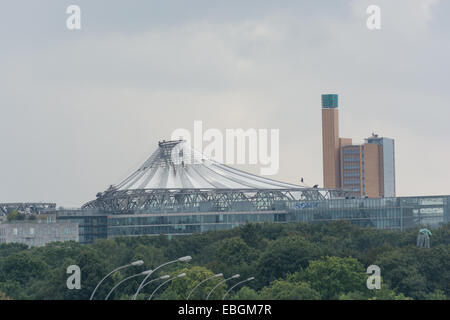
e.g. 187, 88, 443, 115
0, 222, 450, 300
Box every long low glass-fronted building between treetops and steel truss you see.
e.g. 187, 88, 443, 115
57, 195, 450, 243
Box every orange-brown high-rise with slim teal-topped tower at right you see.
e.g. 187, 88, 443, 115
322, 94, 395, 198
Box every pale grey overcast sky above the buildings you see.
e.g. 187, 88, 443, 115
0, 0, 450, 206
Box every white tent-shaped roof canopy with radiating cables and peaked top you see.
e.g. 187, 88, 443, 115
112, 140, 306, 191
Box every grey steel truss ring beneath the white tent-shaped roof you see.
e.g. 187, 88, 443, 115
82, 188, 348, 213
